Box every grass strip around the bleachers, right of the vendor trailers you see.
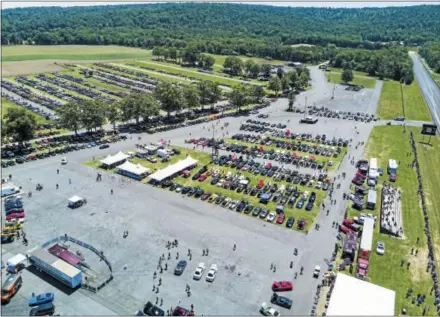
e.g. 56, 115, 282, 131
342, 126, 440, 316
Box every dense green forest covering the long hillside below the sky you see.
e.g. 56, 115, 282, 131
1, 3, 440, 50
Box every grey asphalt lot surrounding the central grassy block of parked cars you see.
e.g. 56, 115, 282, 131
3, 66, 373, 315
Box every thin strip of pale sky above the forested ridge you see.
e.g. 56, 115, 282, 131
2, 0, 440, 9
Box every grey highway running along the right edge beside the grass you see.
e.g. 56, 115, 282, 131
410, 52, 440, 131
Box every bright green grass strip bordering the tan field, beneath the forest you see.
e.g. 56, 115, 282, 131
2, 45, 151, 62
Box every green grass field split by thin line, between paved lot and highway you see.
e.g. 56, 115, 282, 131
377, 80, 431, 121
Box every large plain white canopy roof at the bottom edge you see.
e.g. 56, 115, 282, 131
326, 273, 396, 316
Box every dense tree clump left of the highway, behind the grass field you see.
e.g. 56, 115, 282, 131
329, 46, 414, 84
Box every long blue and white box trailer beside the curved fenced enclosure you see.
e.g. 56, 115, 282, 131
28, 249, 82, 288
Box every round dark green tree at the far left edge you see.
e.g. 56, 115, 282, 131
2, 108, 37, 142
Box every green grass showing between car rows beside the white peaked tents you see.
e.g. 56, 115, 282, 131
83, 146, 327, 230
